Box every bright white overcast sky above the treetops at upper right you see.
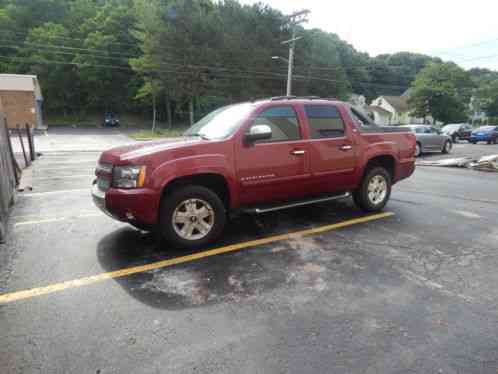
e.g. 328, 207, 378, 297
240, 0, 498, 70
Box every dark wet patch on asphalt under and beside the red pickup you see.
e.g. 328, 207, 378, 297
97, 204, 386, 310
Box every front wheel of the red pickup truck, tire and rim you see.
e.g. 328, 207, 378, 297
158, 185, 227, 248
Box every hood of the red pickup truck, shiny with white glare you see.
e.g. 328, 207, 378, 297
100, 137, 203, 164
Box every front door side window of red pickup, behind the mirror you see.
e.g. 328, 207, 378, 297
252, 106, 301, 143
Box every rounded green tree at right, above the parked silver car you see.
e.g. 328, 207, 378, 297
409, 63, 473, 123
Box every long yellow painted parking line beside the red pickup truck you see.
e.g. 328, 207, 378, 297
0, 212, 394, 304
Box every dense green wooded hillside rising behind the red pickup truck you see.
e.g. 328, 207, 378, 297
0, 0, 450, 125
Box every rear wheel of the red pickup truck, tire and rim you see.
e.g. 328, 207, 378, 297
353, 166, 392, 212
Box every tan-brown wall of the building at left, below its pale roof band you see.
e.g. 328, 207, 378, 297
0, 91, 37, 128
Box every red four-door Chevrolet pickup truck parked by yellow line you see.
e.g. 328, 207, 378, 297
92, 97, 415, 247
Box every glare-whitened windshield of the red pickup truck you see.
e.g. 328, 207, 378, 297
184, 103, 254, 140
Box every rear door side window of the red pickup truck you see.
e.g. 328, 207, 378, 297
304, 105, 344, 139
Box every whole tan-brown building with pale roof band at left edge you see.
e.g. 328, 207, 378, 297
0, 74, 44, 129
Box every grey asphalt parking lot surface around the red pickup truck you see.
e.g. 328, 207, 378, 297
0, 132, 498, 374
